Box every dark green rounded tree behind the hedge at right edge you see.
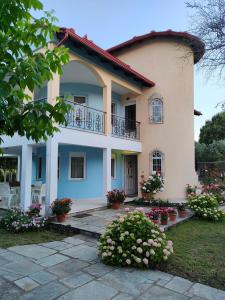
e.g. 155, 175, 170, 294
199, 112, 225, 144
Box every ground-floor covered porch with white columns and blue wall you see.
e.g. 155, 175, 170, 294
0, 141, 138, 214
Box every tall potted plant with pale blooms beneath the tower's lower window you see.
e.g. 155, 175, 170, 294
140, 172, 164, 201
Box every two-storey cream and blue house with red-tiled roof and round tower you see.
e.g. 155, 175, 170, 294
0, 28, 204, 208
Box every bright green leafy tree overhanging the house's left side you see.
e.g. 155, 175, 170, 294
0, 0, 69, 144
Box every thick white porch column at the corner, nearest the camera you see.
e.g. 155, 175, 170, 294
45, 138, 58, 214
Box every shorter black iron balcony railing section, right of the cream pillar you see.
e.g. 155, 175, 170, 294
111, 114, 140, 140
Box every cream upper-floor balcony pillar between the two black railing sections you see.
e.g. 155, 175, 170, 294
103, 80, 112, 135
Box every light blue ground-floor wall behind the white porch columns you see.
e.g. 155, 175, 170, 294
32, 145, 124, 199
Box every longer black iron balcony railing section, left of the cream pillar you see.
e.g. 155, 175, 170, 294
66, 101, 106, 134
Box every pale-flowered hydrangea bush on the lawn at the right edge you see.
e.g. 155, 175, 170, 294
188, 194, 225, 221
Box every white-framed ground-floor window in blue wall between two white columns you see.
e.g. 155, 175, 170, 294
69, 153, 86, 180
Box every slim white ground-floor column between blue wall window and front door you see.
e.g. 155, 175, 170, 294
103, 148, 112, 199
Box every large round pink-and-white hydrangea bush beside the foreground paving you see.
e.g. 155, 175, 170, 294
98, 210, 173, 268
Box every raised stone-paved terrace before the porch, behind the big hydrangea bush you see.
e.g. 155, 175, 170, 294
54, 205, 192, 236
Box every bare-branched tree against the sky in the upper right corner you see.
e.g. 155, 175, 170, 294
186, 0, 225, 75
